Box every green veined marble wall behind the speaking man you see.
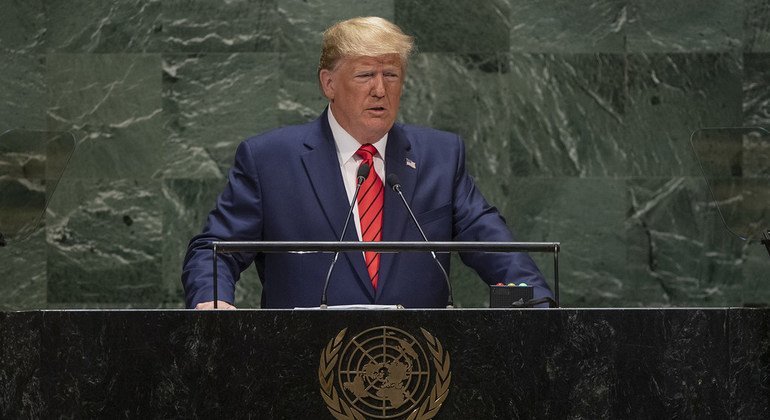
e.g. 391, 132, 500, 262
0, 0, 770, 309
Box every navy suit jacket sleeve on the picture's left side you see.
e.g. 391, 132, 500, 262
182, 141, 263, 308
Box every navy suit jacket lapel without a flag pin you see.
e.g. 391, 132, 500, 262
302, 111, 374, 297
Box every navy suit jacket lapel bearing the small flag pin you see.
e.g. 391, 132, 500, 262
377, 125, 419, 297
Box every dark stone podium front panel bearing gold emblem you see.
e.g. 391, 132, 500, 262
0, 309, 770, 419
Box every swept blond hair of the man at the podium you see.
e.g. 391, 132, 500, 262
318, 16, 414, 74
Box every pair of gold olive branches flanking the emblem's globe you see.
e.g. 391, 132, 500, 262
318, 328, 452, 420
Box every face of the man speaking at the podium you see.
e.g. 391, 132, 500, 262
319, 54, 404, 144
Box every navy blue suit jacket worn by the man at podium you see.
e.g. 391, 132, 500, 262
182, 112, 552, 308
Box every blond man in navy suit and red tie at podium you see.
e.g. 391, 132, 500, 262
182, 17, 552, 309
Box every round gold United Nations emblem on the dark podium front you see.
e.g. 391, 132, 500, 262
318, 326, 452, 420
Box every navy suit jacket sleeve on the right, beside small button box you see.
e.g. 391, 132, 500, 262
453, 133, 553, 298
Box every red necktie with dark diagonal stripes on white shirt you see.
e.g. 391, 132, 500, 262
356, 144, 385, 289
